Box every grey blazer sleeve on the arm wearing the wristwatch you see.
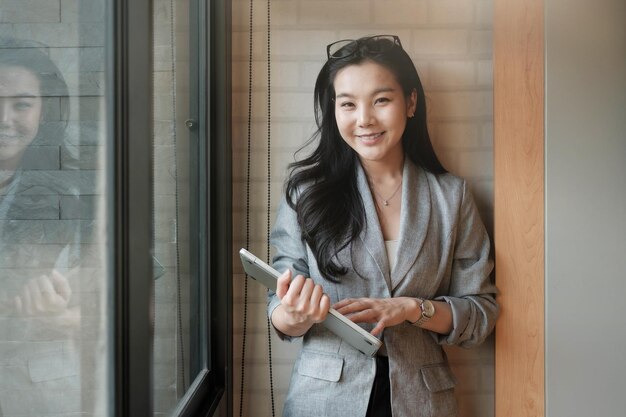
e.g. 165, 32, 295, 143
433, 181, 499, 348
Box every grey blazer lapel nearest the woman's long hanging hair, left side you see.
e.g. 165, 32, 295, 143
357, 163, 391, 288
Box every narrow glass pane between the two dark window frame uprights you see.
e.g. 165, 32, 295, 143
153, 0, 203, 415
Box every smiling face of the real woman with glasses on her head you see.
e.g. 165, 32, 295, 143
333, 61, 417, 166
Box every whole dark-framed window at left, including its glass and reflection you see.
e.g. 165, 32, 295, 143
0, 0, 231, 417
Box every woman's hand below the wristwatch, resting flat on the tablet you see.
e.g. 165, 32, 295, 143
333, 297, 419, 336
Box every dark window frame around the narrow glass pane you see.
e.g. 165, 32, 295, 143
107, 0, 232, 417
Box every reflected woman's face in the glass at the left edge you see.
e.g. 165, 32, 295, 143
0, 65, 42, 162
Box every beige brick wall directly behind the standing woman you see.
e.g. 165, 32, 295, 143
232, 0, 494, 417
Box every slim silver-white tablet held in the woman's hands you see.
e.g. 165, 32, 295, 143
239, 249, 382, 356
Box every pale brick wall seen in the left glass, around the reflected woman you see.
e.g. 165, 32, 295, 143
0, 0, 105, 417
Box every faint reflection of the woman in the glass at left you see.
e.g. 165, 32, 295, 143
0, 38, 80, 417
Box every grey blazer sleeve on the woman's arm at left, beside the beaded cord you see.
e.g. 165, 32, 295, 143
267, 197, 310, 341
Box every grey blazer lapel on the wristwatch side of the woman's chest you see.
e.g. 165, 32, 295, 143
388, 159, 431, 290
